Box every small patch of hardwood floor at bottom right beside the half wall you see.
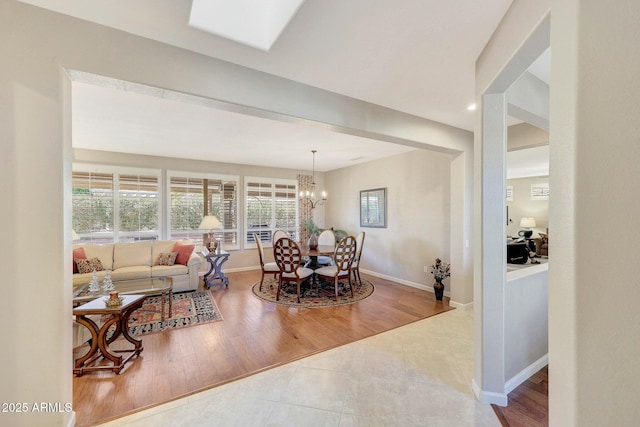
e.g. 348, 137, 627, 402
491, 366, 549, 427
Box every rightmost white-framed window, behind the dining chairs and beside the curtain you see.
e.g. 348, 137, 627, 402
245, 177, 298, 244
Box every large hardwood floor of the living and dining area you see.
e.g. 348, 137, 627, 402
73, 271, 451, 426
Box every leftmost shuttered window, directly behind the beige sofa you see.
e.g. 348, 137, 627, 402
72, 165, 160, 243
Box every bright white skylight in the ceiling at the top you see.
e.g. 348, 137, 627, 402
189, 0, 304, 51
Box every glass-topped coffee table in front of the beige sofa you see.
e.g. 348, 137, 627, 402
73, 277, 173, 320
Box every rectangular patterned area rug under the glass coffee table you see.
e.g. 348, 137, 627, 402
129, 291, 223, 336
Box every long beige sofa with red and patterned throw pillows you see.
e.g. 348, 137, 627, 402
73, 240, 202, 292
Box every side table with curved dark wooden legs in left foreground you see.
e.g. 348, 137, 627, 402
73, 295, 146, 376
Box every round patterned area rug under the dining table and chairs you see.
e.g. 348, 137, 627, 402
251, 277, 375, 308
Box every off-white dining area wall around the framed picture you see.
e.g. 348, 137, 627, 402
324, 150, 459, 292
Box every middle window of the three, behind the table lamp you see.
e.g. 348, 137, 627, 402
167, 171, 239, 249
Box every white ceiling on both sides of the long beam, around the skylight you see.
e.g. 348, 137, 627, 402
23, 0, 544, 174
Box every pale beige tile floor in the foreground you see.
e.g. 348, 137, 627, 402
95, 310, 500, 427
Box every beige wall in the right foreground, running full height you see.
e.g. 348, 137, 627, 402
549, 0, 640, 426
